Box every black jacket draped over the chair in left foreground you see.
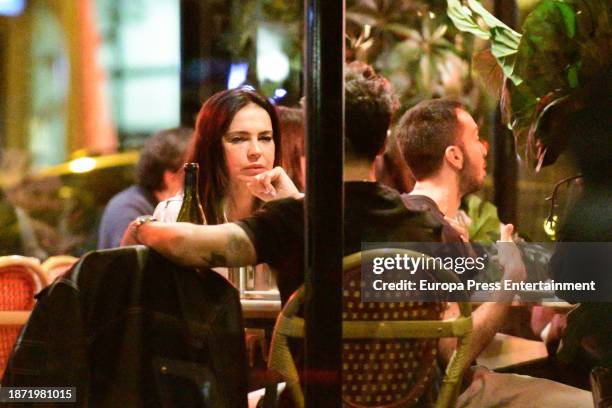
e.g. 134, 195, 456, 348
2, 246, 247, 408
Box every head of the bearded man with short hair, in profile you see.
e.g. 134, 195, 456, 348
396, 98, 487, 195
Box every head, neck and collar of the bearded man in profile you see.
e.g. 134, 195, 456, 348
396, 98, 487, 241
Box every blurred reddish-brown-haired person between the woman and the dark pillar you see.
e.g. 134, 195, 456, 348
278, 106, 306, 191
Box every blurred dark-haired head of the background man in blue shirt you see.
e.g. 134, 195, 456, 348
136, 127, 193, 199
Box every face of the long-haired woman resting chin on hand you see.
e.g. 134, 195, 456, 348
222, 103, 275, 182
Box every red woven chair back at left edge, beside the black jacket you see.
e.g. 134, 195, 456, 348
0, 255, 47, 378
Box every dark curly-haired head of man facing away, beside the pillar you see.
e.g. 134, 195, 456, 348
344, 62, 399, 161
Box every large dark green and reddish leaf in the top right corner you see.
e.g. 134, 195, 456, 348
508, 0, 612, 170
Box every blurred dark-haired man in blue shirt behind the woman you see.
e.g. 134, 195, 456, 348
98, 128, 193, 249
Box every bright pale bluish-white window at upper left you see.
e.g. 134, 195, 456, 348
96, 0, 181, 148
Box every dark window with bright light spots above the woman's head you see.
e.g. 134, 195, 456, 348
181, 0, 303, 119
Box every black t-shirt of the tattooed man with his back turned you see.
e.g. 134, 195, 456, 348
237, 181, 443, 304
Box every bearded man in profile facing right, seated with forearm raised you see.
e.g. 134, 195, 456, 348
395, 98, 591, 407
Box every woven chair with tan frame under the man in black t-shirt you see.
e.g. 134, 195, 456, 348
268, 249, 472, 408
